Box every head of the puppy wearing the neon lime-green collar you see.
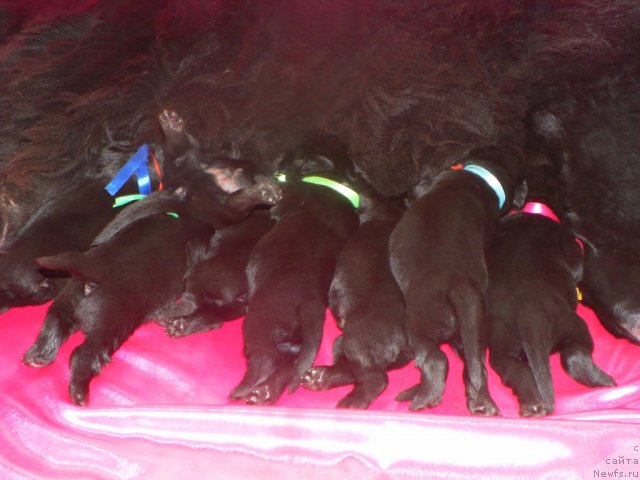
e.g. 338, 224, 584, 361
278, 135, 355, 182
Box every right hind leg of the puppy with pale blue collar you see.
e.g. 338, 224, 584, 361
449, 284, 500, 415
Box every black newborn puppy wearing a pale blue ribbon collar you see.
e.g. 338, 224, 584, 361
389, 146, 523, 415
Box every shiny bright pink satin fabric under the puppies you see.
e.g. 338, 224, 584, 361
0, 306, 640, 480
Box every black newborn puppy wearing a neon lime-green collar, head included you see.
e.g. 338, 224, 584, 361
230, 137, 357, 404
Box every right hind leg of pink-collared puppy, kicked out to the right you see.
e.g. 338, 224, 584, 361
560, 313, 616, 387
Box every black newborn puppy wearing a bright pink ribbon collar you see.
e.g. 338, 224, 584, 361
487, 167, 615, 417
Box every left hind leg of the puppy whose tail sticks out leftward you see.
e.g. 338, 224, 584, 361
22, 301, 77, 367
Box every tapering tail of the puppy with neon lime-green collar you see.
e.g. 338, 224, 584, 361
289, 301, 326, 393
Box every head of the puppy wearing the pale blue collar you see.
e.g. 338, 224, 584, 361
462, 145, 527, 213
